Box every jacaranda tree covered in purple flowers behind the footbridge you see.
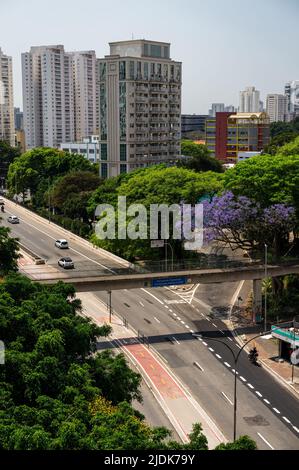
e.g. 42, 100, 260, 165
204, 191, 296, 259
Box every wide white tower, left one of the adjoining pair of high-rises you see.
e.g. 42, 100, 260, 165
22, 45, 74, 148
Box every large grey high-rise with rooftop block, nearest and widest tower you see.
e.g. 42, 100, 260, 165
98, 39, 182, 177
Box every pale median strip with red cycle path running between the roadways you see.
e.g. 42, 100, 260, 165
77, 293, 227, 449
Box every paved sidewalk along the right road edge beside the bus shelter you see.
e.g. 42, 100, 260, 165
227, 298, 299, 398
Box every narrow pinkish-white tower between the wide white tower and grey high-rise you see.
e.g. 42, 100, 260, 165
71, 51, 98, 142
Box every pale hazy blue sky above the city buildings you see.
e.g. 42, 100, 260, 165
0, 0, 299, 114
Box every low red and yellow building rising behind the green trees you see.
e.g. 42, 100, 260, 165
206, 113, 270, 163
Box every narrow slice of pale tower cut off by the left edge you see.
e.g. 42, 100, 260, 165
0, 48, 15, 146
